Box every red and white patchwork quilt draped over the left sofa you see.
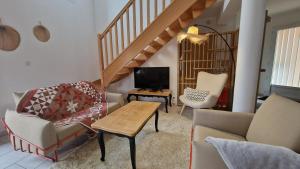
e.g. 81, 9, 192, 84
17, 81, 105, 128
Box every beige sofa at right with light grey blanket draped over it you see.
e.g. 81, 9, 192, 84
191, 94, 300, 169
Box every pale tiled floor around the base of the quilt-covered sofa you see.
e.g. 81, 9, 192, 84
0, 133, 87, 169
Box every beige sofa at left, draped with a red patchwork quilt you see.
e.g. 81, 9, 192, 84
4, 92, 124, 161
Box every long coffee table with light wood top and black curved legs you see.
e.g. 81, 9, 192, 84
92, 101, 160, 169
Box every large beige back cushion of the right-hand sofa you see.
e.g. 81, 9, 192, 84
246, 94, 300, 153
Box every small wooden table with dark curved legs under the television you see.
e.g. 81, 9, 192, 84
127, 89, 172, 113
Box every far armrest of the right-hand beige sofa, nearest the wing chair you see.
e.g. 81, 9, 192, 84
193, 109, 254, 136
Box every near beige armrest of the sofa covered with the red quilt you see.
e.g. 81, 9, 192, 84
5, 110, 57, 149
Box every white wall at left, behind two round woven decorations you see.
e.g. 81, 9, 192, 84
0, 0, 99, 133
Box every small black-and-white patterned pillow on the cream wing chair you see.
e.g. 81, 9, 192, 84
184, 87, 209, 102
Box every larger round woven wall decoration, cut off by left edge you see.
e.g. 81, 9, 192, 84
0, 24, 21, 51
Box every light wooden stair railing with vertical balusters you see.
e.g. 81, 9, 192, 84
98, 0, 174, 77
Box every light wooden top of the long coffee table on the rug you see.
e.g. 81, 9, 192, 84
91, 101, 160, 137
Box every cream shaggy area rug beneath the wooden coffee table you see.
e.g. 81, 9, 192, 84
52, 106, 192, 169
